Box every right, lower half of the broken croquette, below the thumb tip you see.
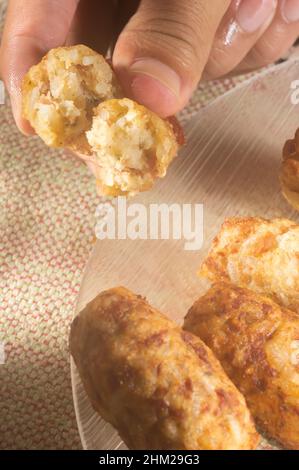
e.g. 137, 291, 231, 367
86, 98, 178, 196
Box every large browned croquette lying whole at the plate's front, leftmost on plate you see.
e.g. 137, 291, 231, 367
70, 287, 259, 450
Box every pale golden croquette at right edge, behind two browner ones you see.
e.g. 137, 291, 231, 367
199, 217, 299, 312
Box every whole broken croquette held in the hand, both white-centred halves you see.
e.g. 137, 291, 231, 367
22, 45, 183, 196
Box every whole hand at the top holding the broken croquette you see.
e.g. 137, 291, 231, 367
0, 0, 299, 133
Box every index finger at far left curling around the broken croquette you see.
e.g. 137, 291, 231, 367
0, 0, 78, 133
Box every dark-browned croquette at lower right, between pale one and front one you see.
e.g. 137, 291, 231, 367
184, 283, 299, 449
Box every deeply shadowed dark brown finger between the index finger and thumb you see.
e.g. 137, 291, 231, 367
66, 0, 117, 55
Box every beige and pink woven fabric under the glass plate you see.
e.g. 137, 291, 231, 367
0, 0, 262, 449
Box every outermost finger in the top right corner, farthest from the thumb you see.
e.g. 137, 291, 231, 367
238, 0, 299, 72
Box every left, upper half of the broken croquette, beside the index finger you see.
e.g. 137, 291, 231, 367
22, 45, 122, 153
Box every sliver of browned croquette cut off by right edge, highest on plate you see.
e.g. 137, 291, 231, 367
280, 129, 299, 210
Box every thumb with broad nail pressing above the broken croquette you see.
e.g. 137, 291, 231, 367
113, 0, 231, 117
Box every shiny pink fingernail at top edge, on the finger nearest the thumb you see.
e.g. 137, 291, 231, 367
236, 0, 277, 33
